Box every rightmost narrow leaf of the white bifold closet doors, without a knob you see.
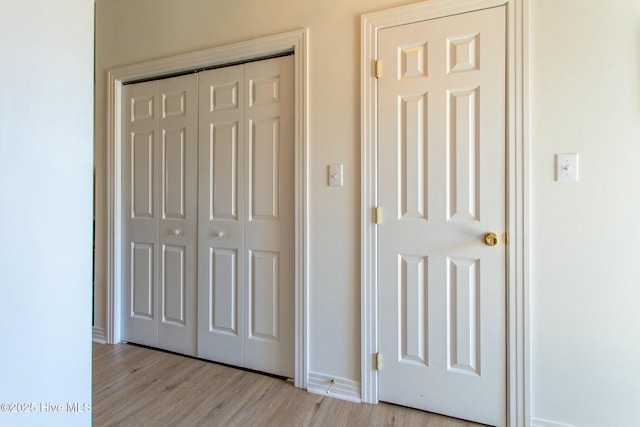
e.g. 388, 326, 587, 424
244, 56, 295, 378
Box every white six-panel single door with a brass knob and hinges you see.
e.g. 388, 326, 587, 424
378, 7, 506, 426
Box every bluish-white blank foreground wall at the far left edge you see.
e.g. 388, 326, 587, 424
0, 0, 93, 427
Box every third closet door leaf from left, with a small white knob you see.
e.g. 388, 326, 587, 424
198, 65, 245, 366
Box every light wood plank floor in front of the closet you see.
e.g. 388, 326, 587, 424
92, 344, 480, 427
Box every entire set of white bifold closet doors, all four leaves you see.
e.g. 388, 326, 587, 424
122, 57, 295, 377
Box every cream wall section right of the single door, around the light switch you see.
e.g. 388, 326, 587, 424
530, 0, 640, 427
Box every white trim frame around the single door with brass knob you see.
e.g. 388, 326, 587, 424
361, 0, 530, 426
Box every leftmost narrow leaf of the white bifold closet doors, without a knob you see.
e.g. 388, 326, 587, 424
122, 82, 159, 346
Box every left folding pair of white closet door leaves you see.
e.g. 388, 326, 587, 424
122, 75, 198, 355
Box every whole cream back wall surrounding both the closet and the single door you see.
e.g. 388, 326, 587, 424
95, 0, 640, 426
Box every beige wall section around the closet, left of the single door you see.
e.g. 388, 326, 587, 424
96, 0, 418, 381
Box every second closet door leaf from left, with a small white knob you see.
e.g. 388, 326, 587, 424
158, 74, 198, 356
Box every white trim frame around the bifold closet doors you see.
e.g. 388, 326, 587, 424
105, 28, 309, 388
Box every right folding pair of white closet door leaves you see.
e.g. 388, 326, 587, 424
198, 56, 294, 377
